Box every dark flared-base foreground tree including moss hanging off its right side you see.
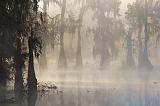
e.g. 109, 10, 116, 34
27, 4, 42, 91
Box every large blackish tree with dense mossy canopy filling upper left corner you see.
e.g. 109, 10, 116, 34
0, 0, 41, 90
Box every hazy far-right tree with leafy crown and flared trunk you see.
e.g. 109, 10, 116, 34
126, 0, 159, 69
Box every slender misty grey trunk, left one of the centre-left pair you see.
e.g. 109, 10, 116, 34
58, 0, 67, 68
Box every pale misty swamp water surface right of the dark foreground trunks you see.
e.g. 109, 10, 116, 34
0, 70, 160, 106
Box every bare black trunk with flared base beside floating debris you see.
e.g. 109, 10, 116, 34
27, 32, 37, 91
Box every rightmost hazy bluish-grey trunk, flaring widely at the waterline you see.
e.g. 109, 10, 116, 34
142, 0, 153, 69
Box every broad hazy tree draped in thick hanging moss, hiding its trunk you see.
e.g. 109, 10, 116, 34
91, 0, 123, 68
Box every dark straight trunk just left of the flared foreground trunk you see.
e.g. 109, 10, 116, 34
14, 38, 24, 91
